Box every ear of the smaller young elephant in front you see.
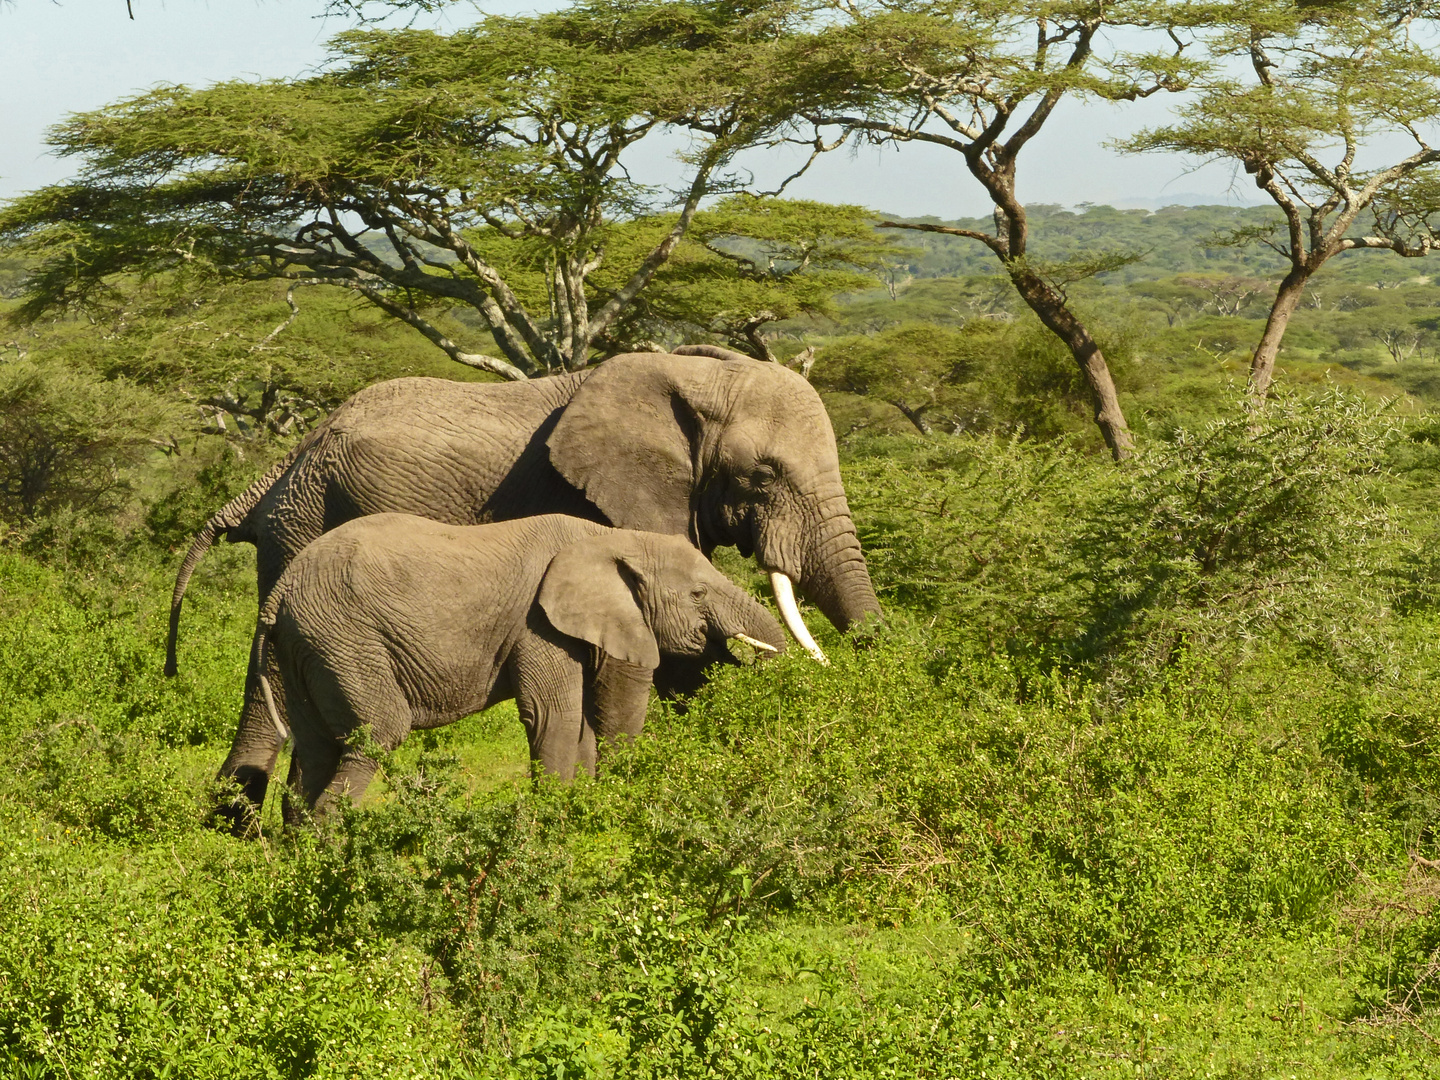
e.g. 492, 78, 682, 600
539, 537, 660, 671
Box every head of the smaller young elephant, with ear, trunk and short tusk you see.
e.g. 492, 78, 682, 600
539, 531, 785, 670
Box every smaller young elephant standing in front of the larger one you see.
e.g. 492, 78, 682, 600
256, 514, 785, 818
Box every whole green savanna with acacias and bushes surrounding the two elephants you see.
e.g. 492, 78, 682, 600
0, 0, 1440, 1080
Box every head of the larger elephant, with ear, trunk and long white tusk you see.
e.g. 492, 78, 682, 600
549, 353, 880, 655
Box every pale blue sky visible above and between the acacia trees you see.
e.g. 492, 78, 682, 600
0, 0, 1256, 217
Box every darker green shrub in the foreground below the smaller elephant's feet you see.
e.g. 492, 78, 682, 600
228, 769, 610, 1041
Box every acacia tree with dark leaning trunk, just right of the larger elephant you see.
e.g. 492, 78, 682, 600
766, 0, 1195, 461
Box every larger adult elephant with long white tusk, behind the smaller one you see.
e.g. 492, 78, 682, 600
166, 347, 880, 831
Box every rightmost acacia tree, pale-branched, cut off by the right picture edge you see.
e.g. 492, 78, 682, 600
1122, 0, 1440, 399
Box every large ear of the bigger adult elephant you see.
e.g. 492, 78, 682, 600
547, 353, 720, 540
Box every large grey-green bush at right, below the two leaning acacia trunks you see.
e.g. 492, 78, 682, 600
1073, 390, 1395, 667
